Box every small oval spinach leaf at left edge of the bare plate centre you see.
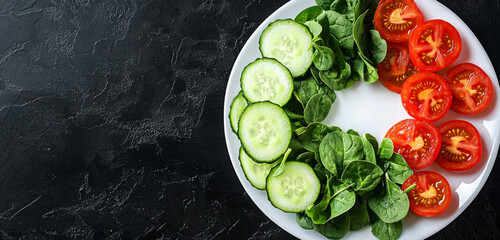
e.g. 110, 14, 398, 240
304, 93, 332, 124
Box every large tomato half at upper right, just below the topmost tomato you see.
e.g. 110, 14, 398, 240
409, 20, 462, 72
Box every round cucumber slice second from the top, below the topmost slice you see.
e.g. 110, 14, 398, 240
241, 58, 293, 106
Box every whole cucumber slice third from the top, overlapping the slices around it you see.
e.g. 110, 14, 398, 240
238, 102, 292, 163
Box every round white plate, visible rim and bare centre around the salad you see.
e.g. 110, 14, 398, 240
224, 0, 500, 239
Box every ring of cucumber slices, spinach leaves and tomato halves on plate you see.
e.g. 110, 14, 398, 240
229, 0, 493, 239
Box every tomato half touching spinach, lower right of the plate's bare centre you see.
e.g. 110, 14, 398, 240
385, 119, 441, 169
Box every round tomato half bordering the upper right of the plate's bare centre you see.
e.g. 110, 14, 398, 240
401, 72, 453, 122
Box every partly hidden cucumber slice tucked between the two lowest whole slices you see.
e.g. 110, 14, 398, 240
238, 148, 280, 190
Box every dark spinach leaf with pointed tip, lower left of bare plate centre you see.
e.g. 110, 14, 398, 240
298, 123, 340, 153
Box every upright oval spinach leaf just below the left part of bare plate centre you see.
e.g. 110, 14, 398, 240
319, 131, 344, 177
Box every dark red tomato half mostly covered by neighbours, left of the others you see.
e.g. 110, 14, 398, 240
377, 42, 418, 93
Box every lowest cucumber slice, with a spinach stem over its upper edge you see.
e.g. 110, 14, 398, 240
266, 161, 321, 212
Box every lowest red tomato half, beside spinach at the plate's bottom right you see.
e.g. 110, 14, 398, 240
401, 171, 451, 217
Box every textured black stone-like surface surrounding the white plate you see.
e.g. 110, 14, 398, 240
0, 0, 500, 239
